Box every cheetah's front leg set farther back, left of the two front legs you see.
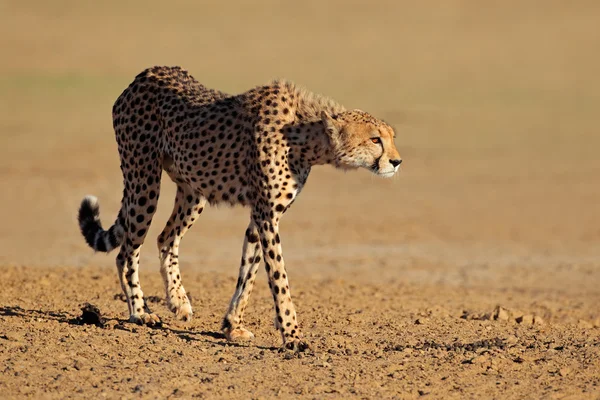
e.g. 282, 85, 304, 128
221, 220, 261, 341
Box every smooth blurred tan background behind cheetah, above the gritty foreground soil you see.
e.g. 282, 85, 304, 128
0, 0, 600, 291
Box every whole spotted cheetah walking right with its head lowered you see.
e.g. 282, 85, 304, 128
78, 66, 402, 351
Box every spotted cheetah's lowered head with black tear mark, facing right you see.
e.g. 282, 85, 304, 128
321, 110, 402, 178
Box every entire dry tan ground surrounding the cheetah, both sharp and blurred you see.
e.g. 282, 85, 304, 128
0, 0, 600, 399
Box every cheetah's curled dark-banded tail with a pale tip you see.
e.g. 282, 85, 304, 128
78, 196, 125, 253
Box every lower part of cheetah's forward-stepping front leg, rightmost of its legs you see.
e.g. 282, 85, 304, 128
257, 216, 309, 351
